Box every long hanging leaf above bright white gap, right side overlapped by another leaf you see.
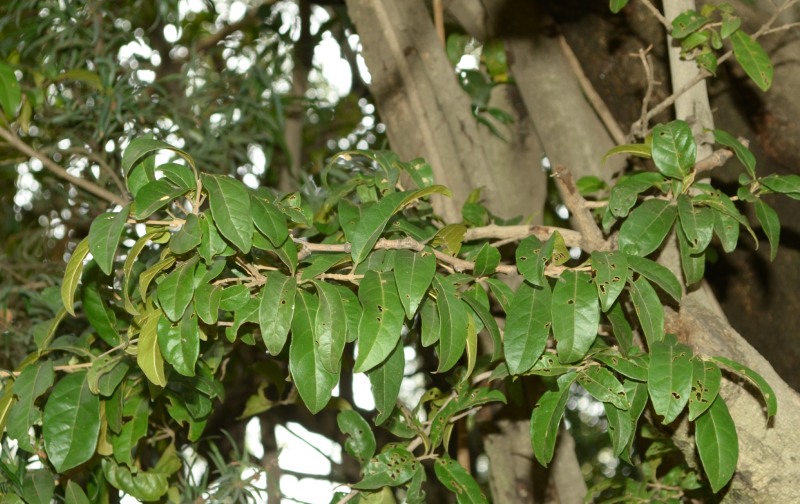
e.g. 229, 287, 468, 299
289, 290, 336, 413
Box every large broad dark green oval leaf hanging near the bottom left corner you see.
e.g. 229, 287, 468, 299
42, 371, 100, 473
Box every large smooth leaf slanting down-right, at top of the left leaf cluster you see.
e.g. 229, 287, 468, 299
202, 174, 254, 254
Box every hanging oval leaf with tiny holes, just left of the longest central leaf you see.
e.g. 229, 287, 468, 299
258, 271, 297, 355
